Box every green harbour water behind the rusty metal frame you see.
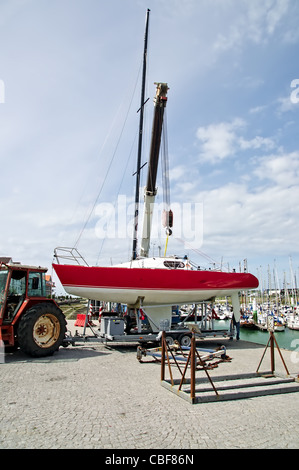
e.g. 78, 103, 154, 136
215, 320, 299, 351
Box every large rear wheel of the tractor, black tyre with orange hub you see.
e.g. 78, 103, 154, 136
17, 302, 66, 357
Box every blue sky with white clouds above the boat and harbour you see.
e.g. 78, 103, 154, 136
0, 0, 299, 293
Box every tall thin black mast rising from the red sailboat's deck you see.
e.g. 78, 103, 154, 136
132, 9, 150, 259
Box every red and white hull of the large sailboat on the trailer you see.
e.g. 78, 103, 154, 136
53, 264, 258, 305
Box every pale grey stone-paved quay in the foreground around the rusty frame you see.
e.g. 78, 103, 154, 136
0, 322, 299, 450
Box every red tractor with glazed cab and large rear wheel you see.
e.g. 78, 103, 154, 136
0, 261, 66, 357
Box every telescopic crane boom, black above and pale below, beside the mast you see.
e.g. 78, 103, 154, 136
140, 83, 168, 257
